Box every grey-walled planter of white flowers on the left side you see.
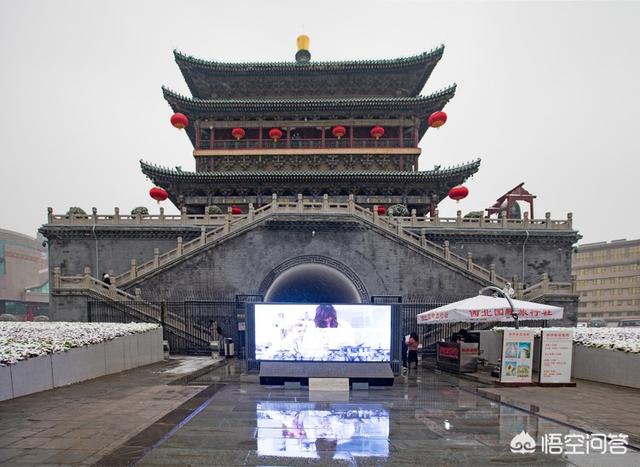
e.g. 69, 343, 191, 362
0, 323, 164, 400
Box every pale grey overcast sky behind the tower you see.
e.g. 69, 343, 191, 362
0, 0, 640, 243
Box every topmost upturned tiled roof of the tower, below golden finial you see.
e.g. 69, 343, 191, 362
174, 45, 444, 99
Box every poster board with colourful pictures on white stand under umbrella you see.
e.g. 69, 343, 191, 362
500, 329, 533, 383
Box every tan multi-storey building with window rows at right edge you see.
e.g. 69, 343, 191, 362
571, 239, 640, 322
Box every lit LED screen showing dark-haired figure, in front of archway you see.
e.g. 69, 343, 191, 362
255, 303, 391, 362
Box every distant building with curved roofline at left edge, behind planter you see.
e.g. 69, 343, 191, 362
0, 229, 49, 320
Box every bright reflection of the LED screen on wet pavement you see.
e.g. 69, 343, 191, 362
256, 402, 389, 461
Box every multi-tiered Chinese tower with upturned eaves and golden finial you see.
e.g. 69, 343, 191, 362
141, 36, 480, 215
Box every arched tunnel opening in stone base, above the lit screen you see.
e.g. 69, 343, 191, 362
264, 263, 362, 303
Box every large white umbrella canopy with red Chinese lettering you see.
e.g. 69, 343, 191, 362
418, 295, 562, 324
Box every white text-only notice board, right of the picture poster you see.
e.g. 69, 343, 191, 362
540, 328, 573, 383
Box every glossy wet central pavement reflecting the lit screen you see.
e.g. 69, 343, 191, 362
140, 363, 640, 466
